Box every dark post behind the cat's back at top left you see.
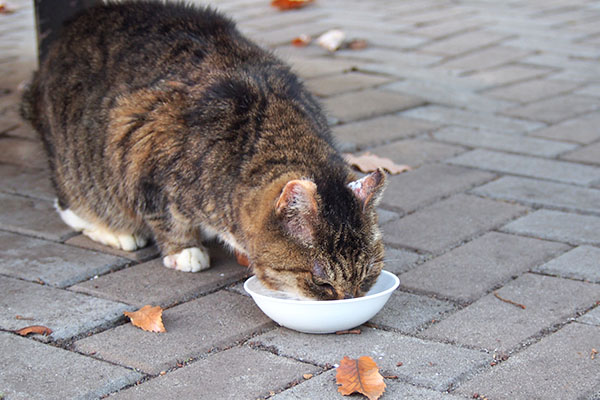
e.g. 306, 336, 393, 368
34, 0, 100, 62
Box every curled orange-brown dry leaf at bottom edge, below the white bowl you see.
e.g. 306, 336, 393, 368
335, 356, 385, 400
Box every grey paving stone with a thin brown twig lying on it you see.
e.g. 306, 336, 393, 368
422, 274, 600, 352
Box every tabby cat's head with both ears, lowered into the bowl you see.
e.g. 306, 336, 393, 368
251, 170, 385, 300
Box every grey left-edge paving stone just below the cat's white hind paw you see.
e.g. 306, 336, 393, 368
0, 231, 129, 288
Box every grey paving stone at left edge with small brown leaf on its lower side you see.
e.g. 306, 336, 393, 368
0, 276, 131, 340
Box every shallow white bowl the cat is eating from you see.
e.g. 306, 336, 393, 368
244, 271, 400, 333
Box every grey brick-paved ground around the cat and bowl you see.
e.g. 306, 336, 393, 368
0, 0, 600, 400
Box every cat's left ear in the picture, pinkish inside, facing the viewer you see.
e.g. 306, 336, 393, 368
275, 179, 317, 245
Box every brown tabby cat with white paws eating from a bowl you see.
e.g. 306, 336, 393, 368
22, 0, 386, 300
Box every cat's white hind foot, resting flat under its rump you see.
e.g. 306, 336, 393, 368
54, 202, 148, 251
